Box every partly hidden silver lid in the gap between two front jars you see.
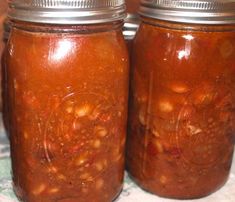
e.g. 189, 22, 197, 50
123, 14, 140, 40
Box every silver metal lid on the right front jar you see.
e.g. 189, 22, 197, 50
139, 0, 235, 24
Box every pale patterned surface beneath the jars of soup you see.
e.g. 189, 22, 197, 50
0, 119, 235, 202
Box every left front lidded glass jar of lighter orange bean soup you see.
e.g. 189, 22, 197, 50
6, 0, 129, 202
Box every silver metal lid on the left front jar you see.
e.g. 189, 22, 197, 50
8, 0, 126, 24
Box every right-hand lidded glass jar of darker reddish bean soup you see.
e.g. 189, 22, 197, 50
127, 0, 235, 199
